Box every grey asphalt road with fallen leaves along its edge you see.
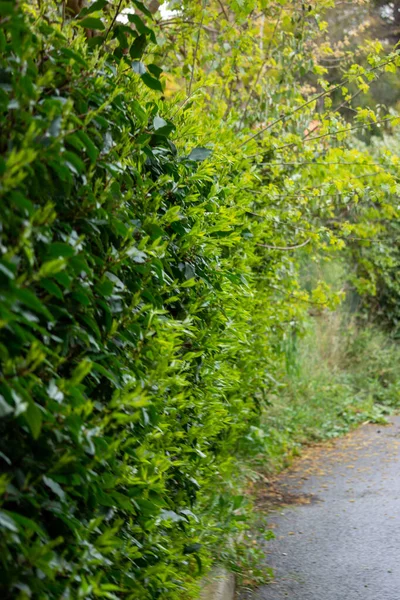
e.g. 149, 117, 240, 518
239, 417, 400, 600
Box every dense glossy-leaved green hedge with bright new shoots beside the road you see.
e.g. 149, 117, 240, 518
0, 2, 276, 600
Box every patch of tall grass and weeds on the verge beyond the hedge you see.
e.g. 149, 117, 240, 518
248, 278, 400, 471
